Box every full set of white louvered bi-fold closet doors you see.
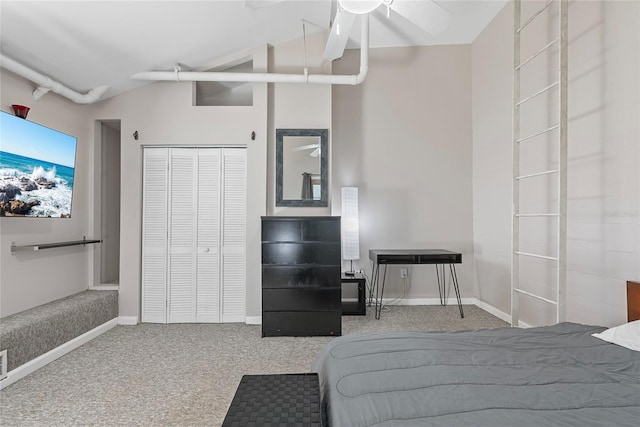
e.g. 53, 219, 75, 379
142, 146, 247, 323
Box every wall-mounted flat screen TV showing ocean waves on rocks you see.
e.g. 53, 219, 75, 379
0, 111, 78, 218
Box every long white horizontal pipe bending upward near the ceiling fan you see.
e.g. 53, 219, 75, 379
131, 15, 369, 85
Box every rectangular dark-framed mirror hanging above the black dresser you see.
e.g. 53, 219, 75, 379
276, 129, 328, 206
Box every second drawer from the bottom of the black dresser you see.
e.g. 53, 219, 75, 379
262, 288, 342, 311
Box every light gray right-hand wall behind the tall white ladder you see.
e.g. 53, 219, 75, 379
472, 1, 640, 325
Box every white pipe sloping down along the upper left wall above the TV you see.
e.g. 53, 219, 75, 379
0, 53, 109, 104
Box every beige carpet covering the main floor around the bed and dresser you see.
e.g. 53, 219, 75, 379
0, 306, 508, 426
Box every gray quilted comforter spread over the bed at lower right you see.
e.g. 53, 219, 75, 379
312, 323, 640, 427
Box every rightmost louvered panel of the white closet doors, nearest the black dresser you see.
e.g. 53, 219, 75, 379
222, 148, 247, 322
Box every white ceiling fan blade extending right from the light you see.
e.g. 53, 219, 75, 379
389, 0, 451, 36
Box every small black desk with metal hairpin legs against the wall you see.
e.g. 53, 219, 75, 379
369, 249, 464, 319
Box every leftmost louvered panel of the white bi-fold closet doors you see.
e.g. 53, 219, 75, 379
142, 148, 169, 323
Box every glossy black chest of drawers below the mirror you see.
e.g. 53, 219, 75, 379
262, 216, 342, 337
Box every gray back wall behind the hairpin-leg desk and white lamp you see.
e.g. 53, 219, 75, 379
331, 45, 473, 298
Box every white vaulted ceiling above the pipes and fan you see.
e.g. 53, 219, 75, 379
0, 0, 506, 101
